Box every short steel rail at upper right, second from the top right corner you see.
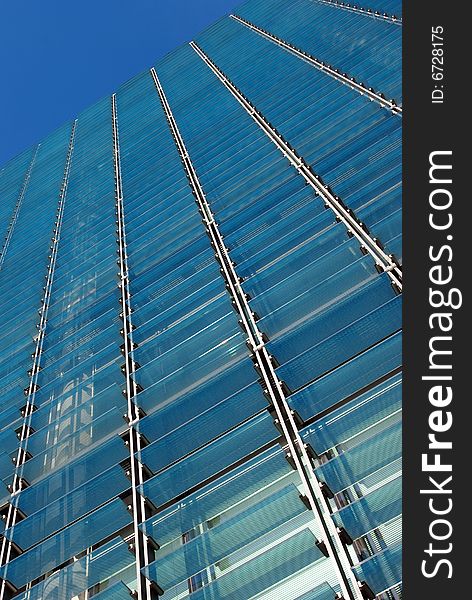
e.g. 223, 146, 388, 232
230, 15, 403, 116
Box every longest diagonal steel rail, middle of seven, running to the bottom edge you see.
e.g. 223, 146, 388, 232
150, 67, 362, 600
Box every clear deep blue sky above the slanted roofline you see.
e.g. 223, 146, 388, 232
0, 0, 240, 165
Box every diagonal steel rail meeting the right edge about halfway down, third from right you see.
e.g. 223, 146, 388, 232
190, 42, 402, 292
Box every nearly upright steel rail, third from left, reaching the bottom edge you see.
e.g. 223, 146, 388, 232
111, 94, 155, 600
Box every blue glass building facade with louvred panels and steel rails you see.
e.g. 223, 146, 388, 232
0, 0, 402, 600
